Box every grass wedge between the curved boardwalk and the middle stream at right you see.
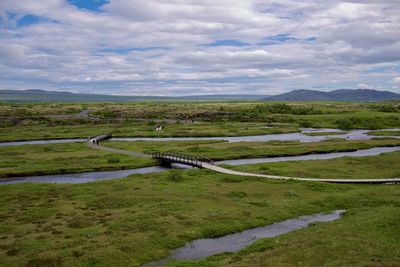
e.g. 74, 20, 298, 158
227, 151, 400, 179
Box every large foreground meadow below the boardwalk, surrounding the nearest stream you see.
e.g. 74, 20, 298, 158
0, 166, 400, 266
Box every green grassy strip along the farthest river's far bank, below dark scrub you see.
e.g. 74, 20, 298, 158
0, 122, 299, 142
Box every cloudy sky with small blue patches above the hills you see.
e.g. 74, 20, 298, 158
0, 0, 400, 96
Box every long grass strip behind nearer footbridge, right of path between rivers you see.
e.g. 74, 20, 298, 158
103, 139, 400, 160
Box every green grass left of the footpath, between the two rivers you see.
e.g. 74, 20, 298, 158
0, 143, 155, 177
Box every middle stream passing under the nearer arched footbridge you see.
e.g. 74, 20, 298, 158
0, 147, 400, 184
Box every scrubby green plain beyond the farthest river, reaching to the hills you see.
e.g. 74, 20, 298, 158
0, 102, 400, 141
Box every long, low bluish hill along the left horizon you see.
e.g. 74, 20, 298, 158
0, 89, 268, 102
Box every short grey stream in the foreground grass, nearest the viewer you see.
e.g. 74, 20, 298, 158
144, 210, 345, 267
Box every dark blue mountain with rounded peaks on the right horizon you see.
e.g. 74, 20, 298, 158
264, 89, 400, 102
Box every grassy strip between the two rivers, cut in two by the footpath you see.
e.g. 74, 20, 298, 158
0, 139, 400, 178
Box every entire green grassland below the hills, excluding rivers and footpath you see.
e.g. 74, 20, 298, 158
0, 102, 400, 267
